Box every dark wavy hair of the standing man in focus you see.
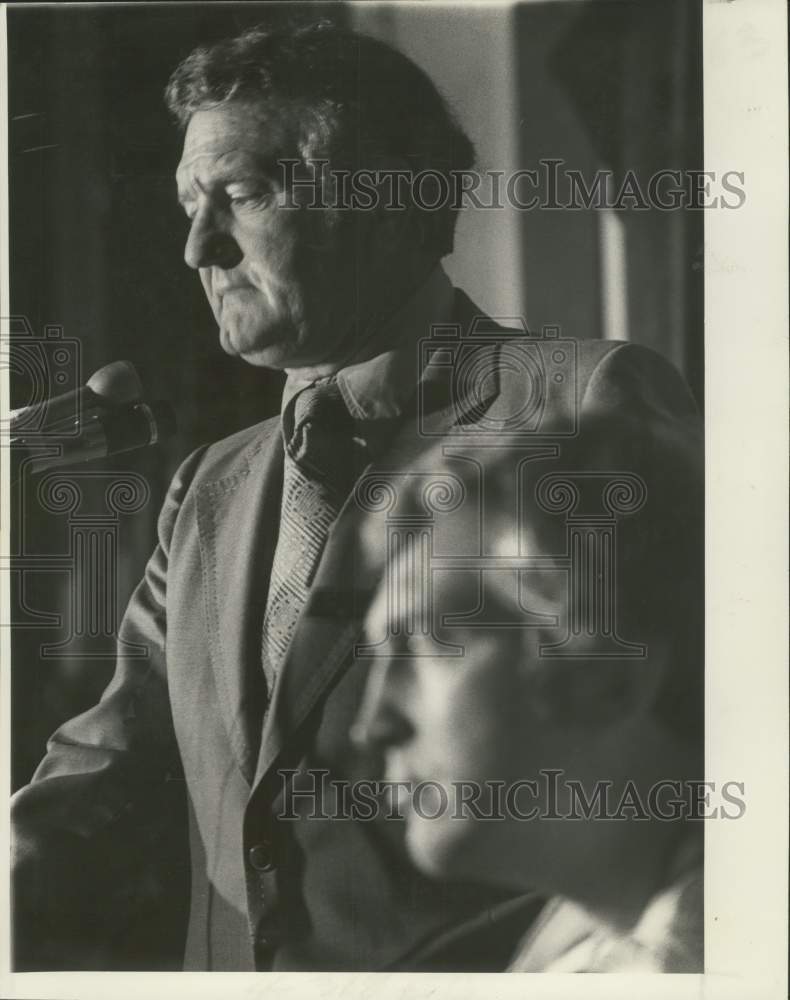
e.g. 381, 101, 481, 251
165, 21, 474, 257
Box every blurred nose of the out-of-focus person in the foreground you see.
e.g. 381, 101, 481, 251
349, 660, 414, 751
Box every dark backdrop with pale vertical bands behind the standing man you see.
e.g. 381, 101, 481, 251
8, 0, 703, 785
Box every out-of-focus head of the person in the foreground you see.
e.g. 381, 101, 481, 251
354, 408, 703, 964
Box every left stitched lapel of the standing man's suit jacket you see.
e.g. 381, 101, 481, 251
197, 421, 283, 784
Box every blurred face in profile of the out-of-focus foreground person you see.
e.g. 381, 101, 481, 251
354, 572, 578, 886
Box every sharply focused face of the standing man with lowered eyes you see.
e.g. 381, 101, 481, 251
176, 102, 357, 369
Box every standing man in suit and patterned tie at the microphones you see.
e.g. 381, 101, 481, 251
13, 19, 692, 970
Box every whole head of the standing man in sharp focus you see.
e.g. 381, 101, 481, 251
166, 22, 474, 375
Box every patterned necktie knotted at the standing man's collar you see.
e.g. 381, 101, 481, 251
261, 381, 367, 700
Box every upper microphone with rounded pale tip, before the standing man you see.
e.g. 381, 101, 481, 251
10, 361, 143, 434
